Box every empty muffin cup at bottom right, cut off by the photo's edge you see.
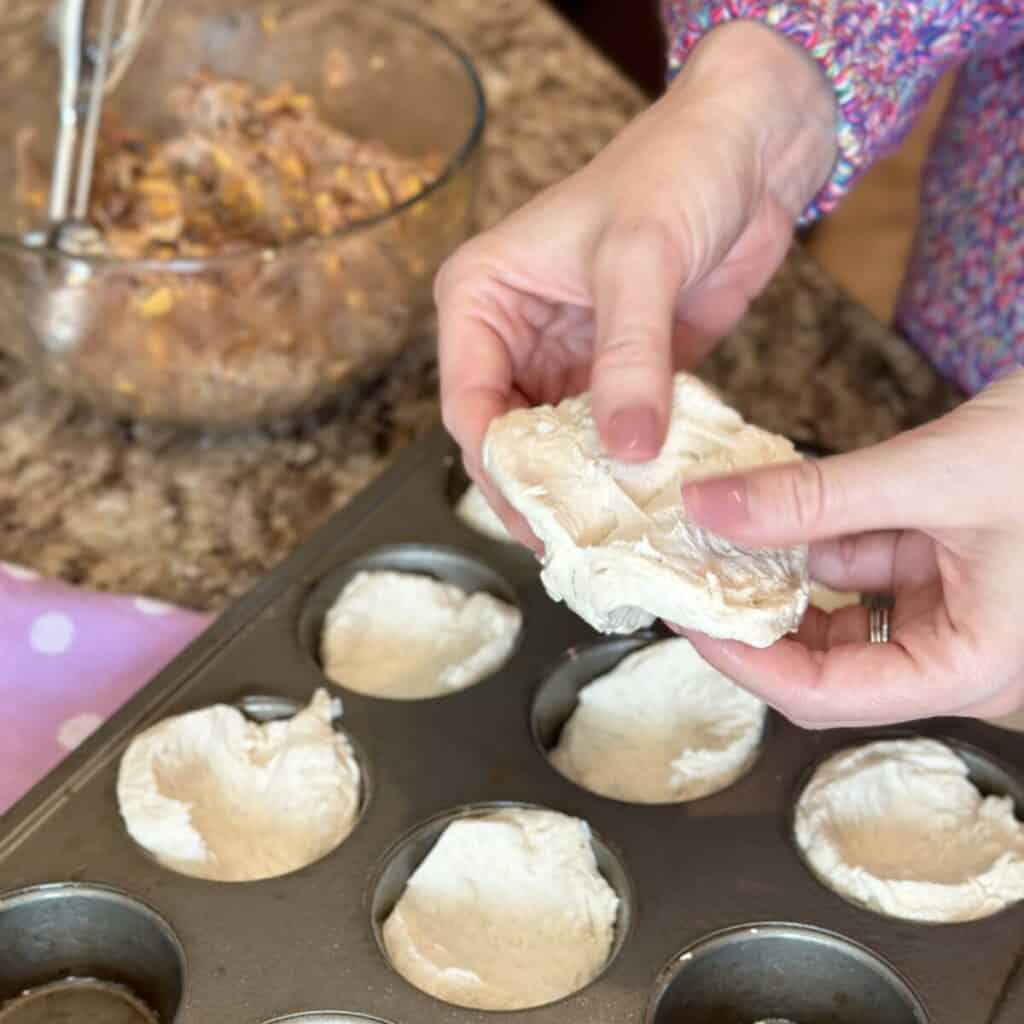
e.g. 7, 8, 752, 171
644, 923, 929, 1024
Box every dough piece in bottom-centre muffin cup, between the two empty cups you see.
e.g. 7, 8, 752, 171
384, 809, 618, 1010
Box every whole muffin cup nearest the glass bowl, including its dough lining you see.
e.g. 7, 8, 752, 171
299, 544, 522, 700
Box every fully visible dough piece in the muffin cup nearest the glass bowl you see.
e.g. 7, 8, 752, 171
321, 571, 522, 700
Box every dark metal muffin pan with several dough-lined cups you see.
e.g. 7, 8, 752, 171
0, 428, 1024, 1024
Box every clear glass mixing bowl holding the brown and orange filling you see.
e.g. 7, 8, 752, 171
0, 0, 484, 427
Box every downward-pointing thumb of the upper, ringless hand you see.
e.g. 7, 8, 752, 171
591, 223, 684, 462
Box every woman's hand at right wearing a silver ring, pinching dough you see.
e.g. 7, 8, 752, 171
683, 371, 1024, 728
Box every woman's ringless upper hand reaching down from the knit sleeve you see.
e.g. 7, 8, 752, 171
436, 23, 836, 540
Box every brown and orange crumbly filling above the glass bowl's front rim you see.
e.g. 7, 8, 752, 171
17, 73, 442, 256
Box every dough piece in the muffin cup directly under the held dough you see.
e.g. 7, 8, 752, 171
551, 637, 766, 804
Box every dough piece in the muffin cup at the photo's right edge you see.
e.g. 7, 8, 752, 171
796, 739, 1024, 922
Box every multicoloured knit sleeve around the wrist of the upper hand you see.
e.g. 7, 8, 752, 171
663, 0, 1024, 220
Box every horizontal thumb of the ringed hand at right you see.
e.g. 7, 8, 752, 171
683, 431, 971, 547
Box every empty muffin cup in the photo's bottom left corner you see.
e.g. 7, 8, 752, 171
0, 883, 185, 1024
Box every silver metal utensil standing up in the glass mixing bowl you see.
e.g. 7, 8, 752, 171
26, 0, 162, 256
